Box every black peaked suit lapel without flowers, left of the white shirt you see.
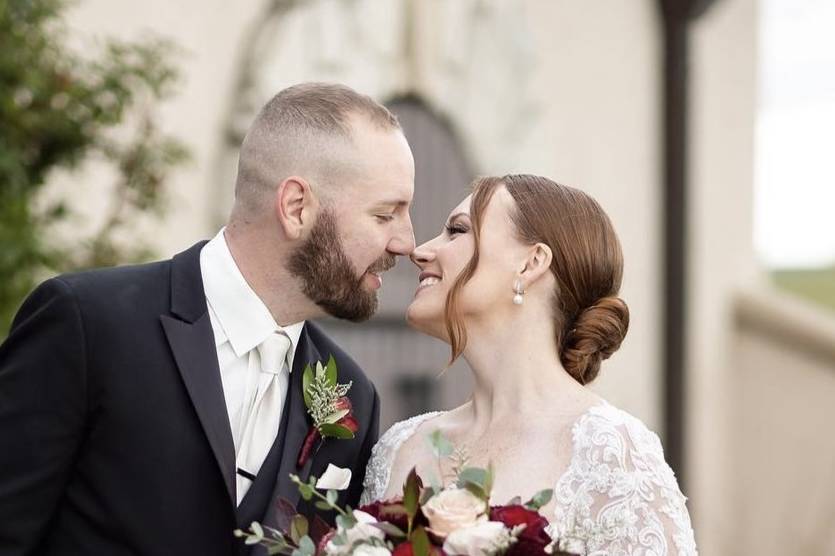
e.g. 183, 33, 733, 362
160, 242, 236, 505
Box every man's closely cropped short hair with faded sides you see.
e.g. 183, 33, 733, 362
235, 83, 400, 215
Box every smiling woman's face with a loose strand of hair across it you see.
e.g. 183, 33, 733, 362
406, 187, 529, 341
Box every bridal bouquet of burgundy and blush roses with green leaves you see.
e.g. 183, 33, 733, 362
235, 432, 567, 556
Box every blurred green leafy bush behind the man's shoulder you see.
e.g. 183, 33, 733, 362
0, 0, 188, 337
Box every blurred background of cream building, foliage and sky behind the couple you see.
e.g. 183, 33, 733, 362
0, 0, 835, 555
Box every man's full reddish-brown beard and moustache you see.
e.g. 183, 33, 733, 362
289, 210, 395, 322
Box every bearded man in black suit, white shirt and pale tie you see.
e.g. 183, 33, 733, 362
0, 83, 414, 556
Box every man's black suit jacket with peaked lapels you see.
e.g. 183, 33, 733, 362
0, 243, 379, 556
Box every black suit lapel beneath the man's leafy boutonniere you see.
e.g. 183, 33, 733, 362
265, 324, 323, 526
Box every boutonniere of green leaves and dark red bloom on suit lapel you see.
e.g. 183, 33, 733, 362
296, 356, 359, 468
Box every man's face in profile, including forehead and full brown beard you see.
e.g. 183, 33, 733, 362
290, 121, 415, 322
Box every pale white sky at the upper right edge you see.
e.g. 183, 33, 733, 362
754, 0, 835, 268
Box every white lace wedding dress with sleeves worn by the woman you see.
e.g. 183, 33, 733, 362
362, 403, 696, 556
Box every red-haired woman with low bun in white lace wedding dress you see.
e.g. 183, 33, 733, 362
363, 175, 696, 556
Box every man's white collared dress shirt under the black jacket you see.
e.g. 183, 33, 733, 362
200, 228, 304, 457
